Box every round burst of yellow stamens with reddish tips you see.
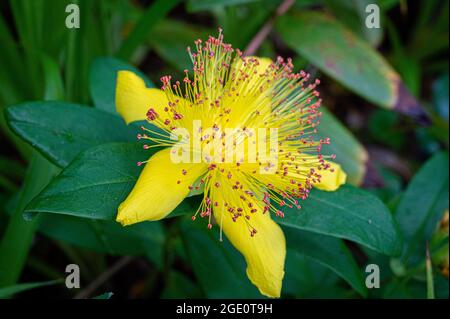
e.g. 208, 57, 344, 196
138, 30, 333, 236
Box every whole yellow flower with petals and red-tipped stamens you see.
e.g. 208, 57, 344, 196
116, 32, 346, 297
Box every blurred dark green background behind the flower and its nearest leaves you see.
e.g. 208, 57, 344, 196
0, 0, 449, 298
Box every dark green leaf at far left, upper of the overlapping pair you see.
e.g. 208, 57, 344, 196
6, 102, 137, 167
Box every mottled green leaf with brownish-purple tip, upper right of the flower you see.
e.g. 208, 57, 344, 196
277, 11, 427, 120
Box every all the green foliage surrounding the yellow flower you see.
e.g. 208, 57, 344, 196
0, 0, 449, 299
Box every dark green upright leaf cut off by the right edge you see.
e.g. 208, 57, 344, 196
395, 153, 449, 265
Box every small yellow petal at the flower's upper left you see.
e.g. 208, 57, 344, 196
116, 71, 168, 124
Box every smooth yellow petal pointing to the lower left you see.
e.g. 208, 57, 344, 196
116, 148, 207, 225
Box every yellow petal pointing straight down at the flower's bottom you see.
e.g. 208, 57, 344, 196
214, 194, 286, 298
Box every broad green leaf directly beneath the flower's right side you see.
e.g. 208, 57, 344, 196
276, 185, 402, 255
